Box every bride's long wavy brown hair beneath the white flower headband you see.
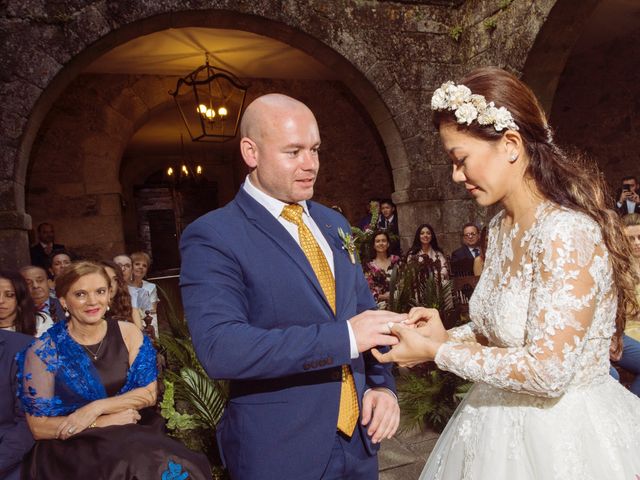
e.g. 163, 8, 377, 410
433, 67, 639, 344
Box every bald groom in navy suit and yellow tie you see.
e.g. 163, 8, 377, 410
180, 94, 406, 480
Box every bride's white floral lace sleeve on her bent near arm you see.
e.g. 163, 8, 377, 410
435, 213, 612, 397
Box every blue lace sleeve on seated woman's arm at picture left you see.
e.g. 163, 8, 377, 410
17, 334, 68, 417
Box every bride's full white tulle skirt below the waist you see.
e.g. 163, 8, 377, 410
420, 375, 640, 480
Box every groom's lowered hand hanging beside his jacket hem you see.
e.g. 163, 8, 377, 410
362, 388, 400, 443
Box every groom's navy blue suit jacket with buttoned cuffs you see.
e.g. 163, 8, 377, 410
181, 189, 395, 480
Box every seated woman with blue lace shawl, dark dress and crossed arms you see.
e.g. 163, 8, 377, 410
18, 262, 211, 480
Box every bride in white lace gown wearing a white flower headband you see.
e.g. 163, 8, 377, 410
373, 68, 640, 480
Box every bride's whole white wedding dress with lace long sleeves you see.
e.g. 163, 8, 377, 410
420, 203, 640, 480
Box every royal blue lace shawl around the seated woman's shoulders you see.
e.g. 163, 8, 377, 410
17, 321, 158, 417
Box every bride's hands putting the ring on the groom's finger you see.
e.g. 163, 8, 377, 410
372, 307, 449, 367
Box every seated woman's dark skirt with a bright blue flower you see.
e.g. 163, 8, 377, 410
21, 410, 211, 480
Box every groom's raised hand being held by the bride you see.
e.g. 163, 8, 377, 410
349, 310, 407, 353
